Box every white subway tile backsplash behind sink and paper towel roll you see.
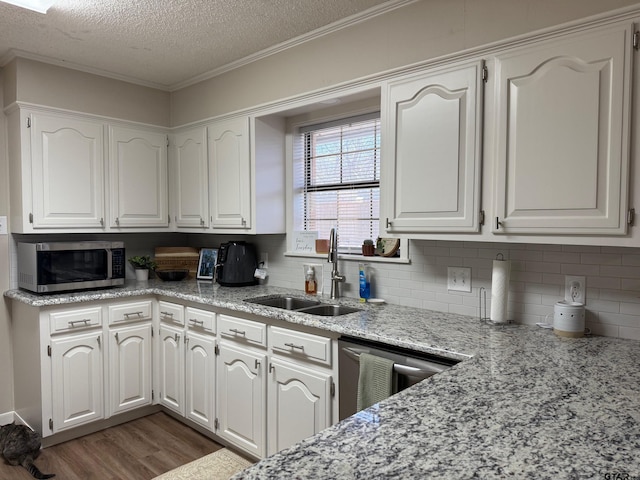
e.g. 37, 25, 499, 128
254, 235, 640, 340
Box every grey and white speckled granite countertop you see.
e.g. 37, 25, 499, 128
5, 282, 640, 480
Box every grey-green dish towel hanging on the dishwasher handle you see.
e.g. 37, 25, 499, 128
357, 353, 394, 411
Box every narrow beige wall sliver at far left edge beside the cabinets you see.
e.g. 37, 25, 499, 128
0, 69, 13, 414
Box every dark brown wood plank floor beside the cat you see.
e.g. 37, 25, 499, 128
0, 412, 222, 480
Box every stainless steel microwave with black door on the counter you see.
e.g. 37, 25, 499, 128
18, 241, 126, 293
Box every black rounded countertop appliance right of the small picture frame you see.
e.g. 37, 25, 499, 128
216, 242, 258, 287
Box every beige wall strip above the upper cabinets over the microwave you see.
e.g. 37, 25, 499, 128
5, 58, 169, 126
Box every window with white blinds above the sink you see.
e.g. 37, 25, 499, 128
294, 112, 380, 253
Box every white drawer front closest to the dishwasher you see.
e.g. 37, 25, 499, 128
269, 327, 331, 366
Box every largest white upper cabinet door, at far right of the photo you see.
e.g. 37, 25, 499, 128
492, 25, 632, 235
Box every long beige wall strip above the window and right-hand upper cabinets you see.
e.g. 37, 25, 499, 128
171, 0, 638, 126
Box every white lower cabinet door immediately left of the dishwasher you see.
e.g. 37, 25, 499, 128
267, 359, 332, 455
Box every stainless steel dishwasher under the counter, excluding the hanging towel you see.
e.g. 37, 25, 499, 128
338, 337, 458, 420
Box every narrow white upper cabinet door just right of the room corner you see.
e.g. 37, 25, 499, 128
171, 127, 209, 228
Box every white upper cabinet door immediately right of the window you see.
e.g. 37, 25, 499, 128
381, 61, 483, 233
